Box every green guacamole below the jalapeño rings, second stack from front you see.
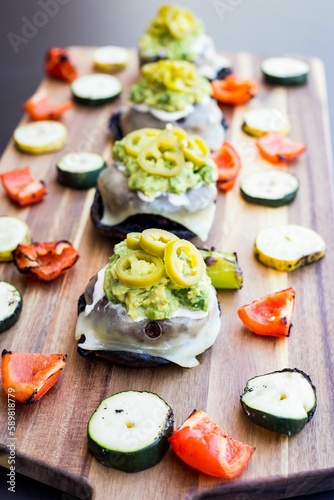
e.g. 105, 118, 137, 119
112, 132, 217, 199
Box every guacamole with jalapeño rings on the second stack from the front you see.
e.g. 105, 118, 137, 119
112, 125, 218, 199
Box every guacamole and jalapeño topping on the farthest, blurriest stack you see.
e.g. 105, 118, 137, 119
139, 4, 204, 61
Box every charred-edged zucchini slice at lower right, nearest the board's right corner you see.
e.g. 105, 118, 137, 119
240, 368, 317, 436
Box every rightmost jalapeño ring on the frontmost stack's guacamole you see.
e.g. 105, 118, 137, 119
165, 239, 205, 288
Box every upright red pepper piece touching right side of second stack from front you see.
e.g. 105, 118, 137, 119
211, 141, 241, 191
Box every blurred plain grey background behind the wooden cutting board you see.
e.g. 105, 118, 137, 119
0, 0, 334, 500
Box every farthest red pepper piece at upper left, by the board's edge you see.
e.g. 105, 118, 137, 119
45, 47, 78, 82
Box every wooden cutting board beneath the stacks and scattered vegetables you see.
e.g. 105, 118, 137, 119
0, 47, 334, 500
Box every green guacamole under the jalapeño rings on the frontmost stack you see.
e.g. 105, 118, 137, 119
103, 241, 212, 320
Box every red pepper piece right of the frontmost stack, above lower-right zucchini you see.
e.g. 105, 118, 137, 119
238, 287, 296, 337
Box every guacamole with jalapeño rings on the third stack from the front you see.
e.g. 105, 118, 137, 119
130, 60, 212, 112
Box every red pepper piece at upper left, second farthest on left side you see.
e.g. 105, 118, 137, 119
23, 90, 73, 120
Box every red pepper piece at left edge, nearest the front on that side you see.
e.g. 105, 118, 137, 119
1, 349, 67, 404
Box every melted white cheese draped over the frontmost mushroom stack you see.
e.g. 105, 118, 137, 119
75, 268, 221, 368
